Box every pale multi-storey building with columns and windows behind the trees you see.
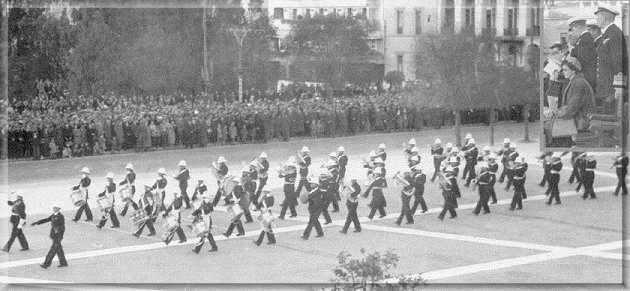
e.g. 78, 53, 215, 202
264, 0, 542, 86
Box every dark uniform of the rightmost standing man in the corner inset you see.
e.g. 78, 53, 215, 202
595, 24, 628, 105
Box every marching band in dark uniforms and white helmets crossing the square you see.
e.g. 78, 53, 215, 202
2, 134, 628, 268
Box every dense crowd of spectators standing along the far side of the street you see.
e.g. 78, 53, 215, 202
2, 86, 540, 159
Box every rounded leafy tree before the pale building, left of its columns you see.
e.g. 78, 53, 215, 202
287, 14, 382, 88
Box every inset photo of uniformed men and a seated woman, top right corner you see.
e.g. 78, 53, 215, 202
541, 1, 629, 151
